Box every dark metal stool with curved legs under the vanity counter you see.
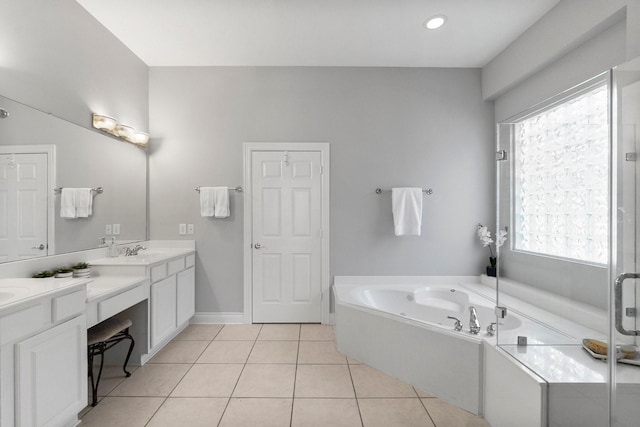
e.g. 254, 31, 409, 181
87, 317, 135, 406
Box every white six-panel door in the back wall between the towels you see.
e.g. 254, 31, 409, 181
251, 151, 322, 323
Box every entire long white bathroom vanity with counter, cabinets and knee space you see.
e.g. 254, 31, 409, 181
0, 241, 195, 427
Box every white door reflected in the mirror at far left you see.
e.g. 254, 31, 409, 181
0, 153, 48, 262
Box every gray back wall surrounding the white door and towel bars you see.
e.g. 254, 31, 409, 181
149, 67, 495, 312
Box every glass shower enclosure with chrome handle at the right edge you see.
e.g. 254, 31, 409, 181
498, 58, 640, 427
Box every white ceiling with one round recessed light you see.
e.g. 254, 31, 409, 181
77, 0, 559, 67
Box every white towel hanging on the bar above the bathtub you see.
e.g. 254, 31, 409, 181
391, 187, 422, 236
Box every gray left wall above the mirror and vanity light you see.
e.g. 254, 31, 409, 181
0, 0, 149, 131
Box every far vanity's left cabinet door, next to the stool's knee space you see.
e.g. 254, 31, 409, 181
151, 276, 176, 348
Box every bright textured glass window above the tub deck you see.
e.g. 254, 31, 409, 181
512, 83, 609, 264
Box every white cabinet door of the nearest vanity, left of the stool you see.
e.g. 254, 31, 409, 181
15, 315, 87, 426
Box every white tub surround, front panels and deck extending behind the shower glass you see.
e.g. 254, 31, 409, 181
334, 276, 640, 427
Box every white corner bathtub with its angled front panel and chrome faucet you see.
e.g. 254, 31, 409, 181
333, 276, 522, 415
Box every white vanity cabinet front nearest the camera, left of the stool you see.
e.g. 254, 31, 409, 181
0, 279, 87, 427
